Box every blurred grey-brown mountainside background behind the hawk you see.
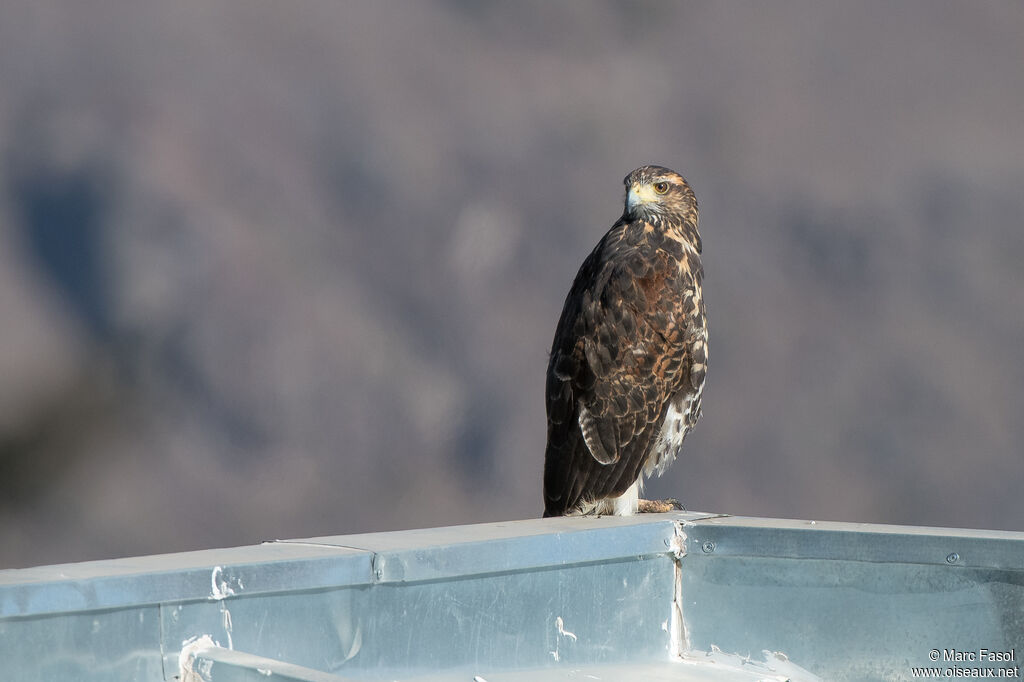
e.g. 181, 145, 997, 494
0, 0, 1024, 567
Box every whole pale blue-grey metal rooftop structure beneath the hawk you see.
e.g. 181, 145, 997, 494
0, 513, 1024, 682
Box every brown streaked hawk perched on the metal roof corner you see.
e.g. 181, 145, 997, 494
544, 166, 708, 516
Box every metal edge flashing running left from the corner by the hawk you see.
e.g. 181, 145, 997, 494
0, 513, 720, 619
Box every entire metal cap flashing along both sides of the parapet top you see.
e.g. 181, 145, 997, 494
0, 512, 1024, 619
